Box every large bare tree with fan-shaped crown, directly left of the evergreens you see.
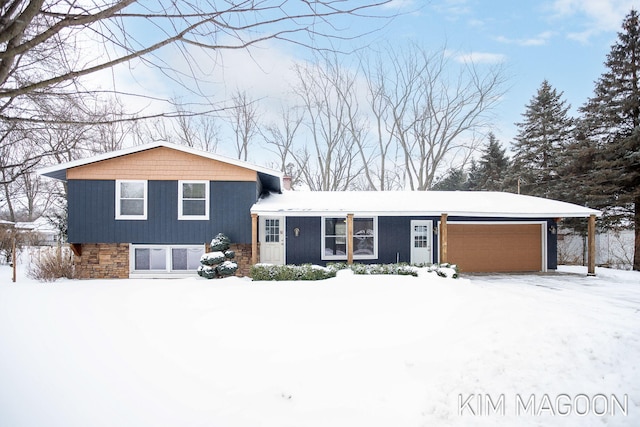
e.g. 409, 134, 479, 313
375, 47, 504, 190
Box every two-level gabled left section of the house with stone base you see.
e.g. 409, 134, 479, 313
40, 143, 282, 278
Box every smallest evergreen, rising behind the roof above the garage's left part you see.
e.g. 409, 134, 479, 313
476, 133, 509, 191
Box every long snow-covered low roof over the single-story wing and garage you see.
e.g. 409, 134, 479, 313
251, 191, 601, 218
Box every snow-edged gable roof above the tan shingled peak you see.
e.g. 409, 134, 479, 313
38, 141, 282, 181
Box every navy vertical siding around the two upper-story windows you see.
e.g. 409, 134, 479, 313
68, 180, 257, 244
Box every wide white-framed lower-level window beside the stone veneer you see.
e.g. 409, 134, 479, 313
130, 245, 204, 274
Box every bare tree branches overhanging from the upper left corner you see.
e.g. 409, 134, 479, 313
0, 0, 390, 121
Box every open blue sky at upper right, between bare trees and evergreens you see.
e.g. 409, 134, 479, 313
385, 0, 640, 149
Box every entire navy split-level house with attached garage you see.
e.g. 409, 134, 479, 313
40, 142, 600, 278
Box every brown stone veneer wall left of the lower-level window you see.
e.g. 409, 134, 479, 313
73, 243, 129, 279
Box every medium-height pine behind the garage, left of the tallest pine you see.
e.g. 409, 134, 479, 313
510, 80, 573, 197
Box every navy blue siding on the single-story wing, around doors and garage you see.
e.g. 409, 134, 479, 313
286, 216, 558, 270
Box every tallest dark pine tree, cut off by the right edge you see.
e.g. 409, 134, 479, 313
581, 10, 640, 270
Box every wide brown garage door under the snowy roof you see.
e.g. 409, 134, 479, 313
447, 223, 544, 272
